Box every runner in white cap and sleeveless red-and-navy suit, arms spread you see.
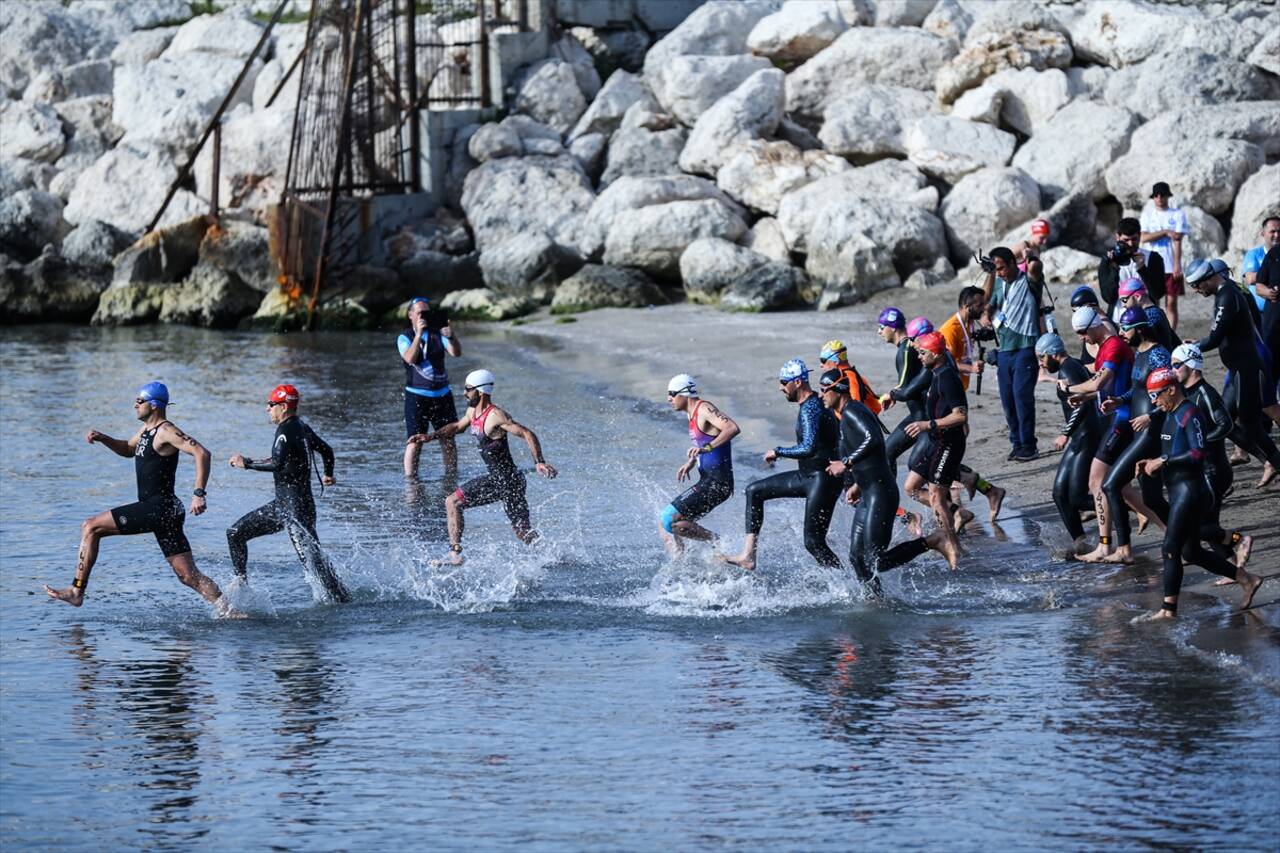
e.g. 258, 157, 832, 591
408, 370, 556, 565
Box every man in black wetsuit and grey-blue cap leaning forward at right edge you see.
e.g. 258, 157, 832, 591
1185, 260, 1280, 487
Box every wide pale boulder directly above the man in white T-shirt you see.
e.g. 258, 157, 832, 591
1106, 138, 1263, 214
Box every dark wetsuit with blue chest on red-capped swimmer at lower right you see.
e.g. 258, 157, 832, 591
1160, 400, 1236, 597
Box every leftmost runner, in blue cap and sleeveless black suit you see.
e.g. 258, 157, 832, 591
45, 382, 230, 616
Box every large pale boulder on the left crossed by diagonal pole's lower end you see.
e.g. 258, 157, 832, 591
63, 143, 207, 234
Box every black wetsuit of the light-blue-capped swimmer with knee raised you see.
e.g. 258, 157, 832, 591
746, 393, 841, 566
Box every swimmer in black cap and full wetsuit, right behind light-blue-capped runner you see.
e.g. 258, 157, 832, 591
822, 370, 959, 584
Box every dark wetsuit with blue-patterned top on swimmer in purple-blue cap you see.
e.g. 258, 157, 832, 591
1102, 343, 1170, 546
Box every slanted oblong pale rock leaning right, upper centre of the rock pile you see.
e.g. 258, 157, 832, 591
680, 68, 786, 175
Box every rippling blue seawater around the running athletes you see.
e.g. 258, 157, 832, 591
0, 327, 1280, 850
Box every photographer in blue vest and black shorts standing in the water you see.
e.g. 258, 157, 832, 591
397, 296, 462, 482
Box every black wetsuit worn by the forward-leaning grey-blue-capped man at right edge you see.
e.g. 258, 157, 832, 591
1198, 282, 1280, 466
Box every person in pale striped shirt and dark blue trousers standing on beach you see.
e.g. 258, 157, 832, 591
982, 246, 1044, 462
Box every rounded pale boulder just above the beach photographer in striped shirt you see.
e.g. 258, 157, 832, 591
938, 167, 1041, 265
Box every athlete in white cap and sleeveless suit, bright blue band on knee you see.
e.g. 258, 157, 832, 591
658, 373, 739, 556
